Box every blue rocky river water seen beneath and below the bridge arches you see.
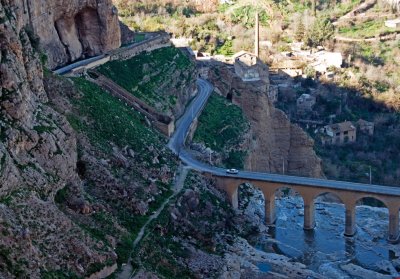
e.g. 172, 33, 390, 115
240, 186, 400, 279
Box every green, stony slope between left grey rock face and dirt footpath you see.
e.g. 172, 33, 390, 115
51, 75, 177, 274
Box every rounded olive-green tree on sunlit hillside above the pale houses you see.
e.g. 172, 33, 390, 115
304, 18, 335, 47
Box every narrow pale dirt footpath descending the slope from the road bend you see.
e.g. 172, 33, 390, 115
117, 164, 190, 279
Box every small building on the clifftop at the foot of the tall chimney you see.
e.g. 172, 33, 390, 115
233, 51, 269, 83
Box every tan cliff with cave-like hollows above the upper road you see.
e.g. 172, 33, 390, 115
8, 0, 121, 69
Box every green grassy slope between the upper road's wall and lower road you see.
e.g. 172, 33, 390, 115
98, 47, 196, 113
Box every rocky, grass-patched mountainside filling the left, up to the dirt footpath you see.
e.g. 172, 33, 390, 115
0, 0, 184, 279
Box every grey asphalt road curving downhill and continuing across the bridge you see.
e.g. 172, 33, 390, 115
168, 79, 400, 197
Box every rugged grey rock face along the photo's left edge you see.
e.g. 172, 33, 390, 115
0, 1, 76, 203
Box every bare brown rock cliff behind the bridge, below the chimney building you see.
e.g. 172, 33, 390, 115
210, 66, 323, 177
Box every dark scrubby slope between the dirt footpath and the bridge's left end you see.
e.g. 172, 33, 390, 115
133, 172, 255, 279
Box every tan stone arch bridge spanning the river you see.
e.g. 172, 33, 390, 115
212, 172, 400, 243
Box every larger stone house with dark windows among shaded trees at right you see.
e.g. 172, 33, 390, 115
321, 121, 357, 144
